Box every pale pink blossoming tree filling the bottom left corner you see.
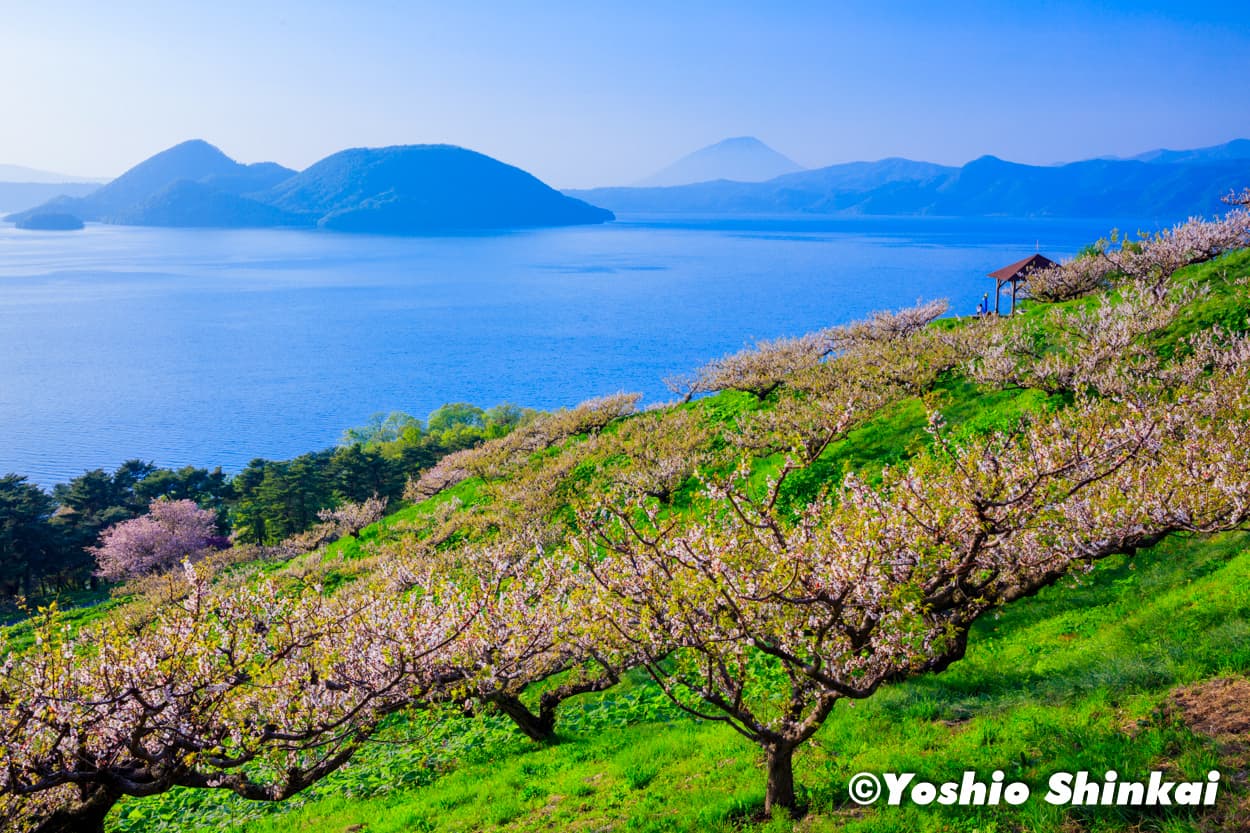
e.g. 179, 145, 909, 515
0, 564, 475, 833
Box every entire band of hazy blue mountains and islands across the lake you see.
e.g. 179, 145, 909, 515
0, 138, 1250, 228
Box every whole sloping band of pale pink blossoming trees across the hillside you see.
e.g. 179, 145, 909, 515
0, 207, 1250, 830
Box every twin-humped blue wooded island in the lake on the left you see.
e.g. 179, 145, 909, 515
5, 140, 613, 234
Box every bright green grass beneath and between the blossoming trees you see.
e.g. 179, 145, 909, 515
105, 251, 1250, 833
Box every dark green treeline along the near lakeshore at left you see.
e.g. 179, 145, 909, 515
0, 403, 536, 610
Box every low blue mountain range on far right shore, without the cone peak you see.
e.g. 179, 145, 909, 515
566, 139, 1250, 218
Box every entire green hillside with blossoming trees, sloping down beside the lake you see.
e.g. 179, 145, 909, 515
0, 211, 1250, 833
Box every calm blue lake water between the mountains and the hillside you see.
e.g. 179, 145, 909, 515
0, 218, 1141, 485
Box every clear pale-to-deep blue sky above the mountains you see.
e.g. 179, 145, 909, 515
0, 0, 1250, 188
